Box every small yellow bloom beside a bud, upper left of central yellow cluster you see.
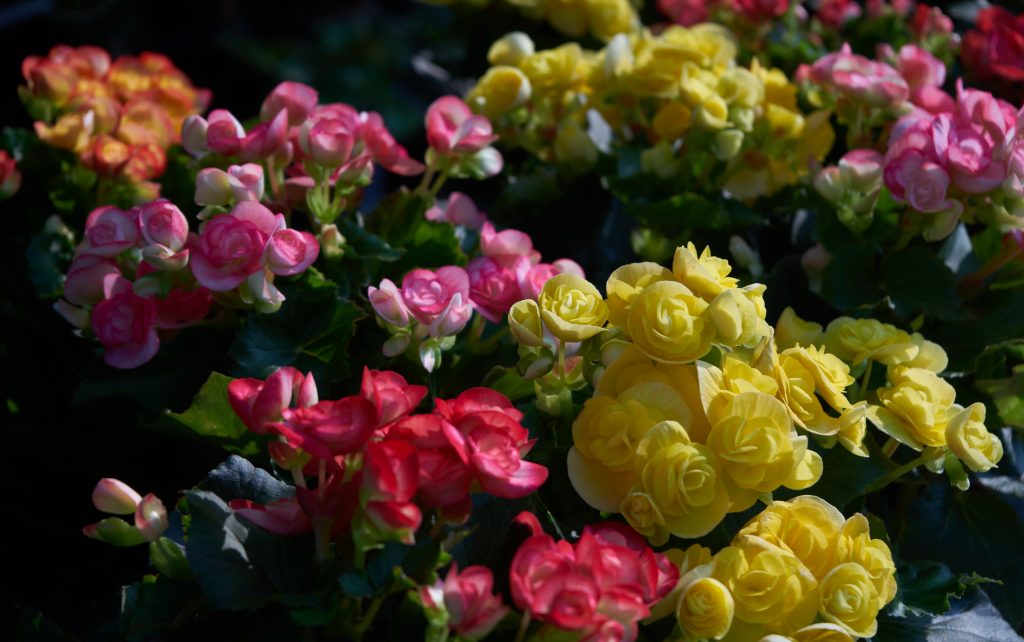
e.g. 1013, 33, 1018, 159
537, 273, 608, 341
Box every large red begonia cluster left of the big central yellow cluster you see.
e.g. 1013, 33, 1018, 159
227, 368, 548, 559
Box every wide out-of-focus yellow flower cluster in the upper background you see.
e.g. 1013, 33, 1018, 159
467, 24, 835, 200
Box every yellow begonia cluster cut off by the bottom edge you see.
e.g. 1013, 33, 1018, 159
653, 496, 896, 642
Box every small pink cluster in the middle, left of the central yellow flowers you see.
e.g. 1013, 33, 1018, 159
368, 191, 583, 372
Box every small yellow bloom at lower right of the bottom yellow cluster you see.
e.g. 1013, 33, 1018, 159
818, 562, 879, 638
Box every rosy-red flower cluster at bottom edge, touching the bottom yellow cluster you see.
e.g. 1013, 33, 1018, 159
509, 513, 679, 642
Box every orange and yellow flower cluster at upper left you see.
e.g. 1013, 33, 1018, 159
19, 45, 210, 193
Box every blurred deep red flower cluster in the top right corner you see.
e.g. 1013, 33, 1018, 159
962, 6, 1024, 99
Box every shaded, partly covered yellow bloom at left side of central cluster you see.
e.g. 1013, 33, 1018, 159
568, 382, 690, 513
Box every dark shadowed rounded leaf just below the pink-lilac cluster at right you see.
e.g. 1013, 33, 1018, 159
879, 248, 961, 318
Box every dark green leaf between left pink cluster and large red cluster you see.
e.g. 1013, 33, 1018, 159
228, 269, 366, 386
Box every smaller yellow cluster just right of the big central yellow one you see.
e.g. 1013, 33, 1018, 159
776, 309, 1002, 479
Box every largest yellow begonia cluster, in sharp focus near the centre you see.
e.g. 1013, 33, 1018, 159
509, 244, 866, 545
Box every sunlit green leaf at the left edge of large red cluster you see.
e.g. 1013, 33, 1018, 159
161, 373, 263, 455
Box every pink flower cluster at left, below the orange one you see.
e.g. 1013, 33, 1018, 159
56, 195, 319, 369
